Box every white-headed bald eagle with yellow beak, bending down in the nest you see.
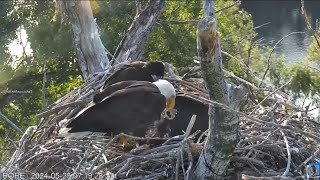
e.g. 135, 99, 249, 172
59, 79, 176, 138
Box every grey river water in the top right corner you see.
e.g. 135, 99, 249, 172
240, 0, 320, 63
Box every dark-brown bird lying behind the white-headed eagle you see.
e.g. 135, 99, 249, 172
104, 61, 164, 88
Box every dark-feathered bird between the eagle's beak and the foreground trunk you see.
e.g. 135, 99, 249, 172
167, 94, 209, 136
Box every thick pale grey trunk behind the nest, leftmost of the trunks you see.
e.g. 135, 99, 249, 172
59, 0, 110, 81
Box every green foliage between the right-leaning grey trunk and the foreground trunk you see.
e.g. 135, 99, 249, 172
145, 1, 202, 66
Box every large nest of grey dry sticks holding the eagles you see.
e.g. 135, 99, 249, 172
2, 62, 320, 179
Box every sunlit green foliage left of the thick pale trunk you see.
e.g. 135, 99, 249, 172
0, 1, 82, 161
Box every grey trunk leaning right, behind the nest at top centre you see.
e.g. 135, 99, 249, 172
114, 0, 166, 63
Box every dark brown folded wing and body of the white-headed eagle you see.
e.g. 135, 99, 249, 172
67, 83, 166, 136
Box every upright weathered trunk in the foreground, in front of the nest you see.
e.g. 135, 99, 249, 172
192, 0, 243, 180
